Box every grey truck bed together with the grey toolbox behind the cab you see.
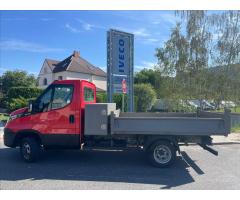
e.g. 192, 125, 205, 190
85, 104, 231, 136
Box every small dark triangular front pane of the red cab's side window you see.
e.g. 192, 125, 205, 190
34, 88, 53, 112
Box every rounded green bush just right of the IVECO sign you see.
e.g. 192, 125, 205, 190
134, 83, 157, 112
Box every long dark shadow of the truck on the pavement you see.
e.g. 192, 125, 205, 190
0, 148, 203, 189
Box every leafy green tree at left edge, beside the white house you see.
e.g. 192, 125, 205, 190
1, 70, 37, 95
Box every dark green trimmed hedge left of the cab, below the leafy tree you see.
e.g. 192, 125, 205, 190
7, 87, 42, 100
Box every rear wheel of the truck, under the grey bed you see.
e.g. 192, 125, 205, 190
147, 140, 176, 168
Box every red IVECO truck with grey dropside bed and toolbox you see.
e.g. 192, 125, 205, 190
4, 80, 230, 167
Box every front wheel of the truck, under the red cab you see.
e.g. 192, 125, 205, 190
20, 137, 41, 162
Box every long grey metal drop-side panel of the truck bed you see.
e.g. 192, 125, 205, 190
111, 112, 230, 136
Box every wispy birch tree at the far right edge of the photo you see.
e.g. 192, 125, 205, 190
211, 11, 240, 102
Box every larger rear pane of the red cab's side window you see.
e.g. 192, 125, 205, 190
51, 85, 73, 109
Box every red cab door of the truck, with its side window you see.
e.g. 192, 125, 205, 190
32, 82, 79, 147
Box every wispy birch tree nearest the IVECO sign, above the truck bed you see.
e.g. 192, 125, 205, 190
156, 11, 214, 109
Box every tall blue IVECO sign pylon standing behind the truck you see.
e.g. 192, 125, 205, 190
107, 29, 133, 111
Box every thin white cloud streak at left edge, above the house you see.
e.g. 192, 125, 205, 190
0, 40, 64, 53
